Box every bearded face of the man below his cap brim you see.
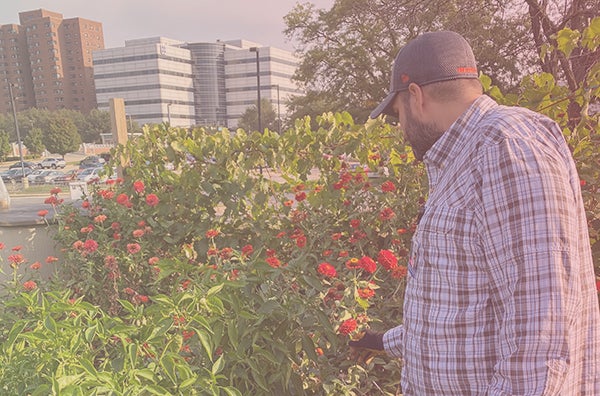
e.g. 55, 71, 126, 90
392, 93, 444, 161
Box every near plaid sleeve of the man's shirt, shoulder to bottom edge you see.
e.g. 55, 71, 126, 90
478, 135, 580, 395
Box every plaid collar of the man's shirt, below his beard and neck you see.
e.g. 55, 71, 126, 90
423, 95, 498, 172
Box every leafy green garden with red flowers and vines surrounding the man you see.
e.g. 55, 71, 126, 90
0, 19, 600, 395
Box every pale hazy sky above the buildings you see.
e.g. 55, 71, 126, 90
0, 0, 334, 50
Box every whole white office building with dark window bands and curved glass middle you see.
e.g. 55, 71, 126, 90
94, 37, 299, 128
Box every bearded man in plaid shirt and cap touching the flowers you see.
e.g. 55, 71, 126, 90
350, 31, 600, 396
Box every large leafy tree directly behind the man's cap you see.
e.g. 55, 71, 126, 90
285, 0, 535, 122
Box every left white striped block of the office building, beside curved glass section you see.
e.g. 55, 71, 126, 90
93, 37, 196, 127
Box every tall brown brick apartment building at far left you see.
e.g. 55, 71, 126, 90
0, 9, 104, 113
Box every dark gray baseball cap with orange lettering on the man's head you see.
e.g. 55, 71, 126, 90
371, 31, 479, 118
